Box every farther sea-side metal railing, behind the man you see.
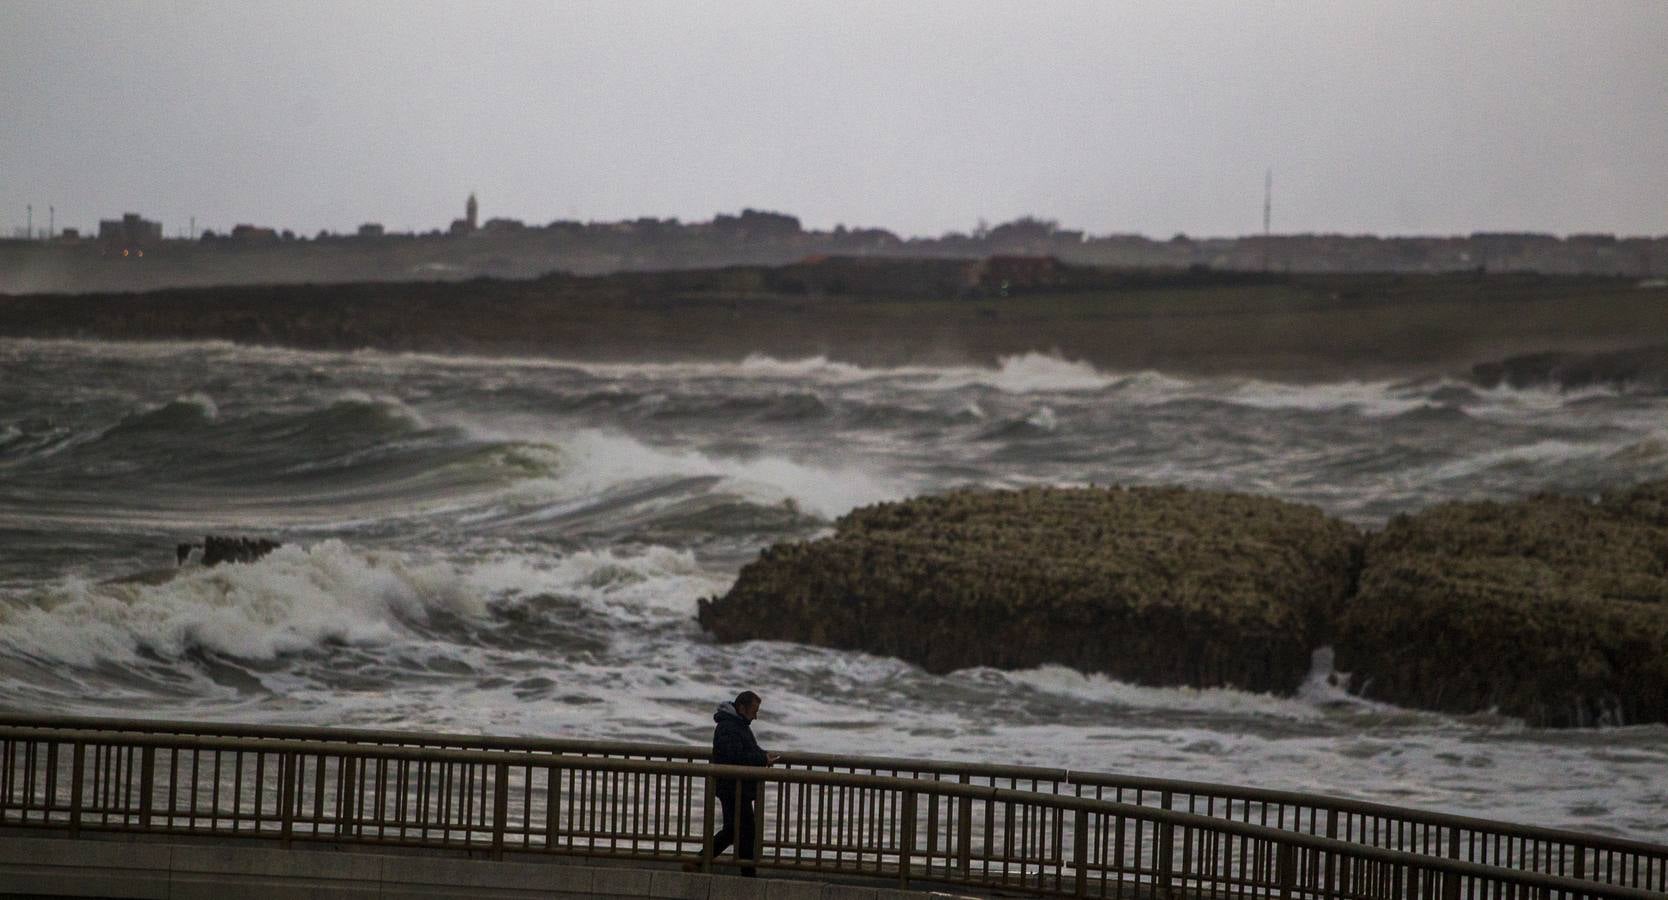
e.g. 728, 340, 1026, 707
0, 713, 1668, 893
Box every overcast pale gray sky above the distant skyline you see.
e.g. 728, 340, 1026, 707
0, 0, 1668, 237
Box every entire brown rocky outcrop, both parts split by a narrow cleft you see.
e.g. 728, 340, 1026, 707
699, 482, 1668, 727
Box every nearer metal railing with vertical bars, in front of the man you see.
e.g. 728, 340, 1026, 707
0, 725, 1668, 900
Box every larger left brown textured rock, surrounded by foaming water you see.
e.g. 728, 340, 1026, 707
699, 488, 1361, 692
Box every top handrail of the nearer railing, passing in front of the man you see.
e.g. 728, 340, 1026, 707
0, 725, 1668, 900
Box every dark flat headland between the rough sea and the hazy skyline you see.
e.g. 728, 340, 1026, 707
0, 260, 1668, 380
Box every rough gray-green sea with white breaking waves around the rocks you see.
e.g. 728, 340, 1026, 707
0, 340, 1668, 842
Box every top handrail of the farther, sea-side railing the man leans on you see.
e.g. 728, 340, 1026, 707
0, 713, 1668, 858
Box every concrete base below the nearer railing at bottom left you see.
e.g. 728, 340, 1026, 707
0, 830, 980, 900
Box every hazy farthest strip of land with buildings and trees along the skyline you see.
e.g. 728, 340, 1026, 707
0, 210, 1668, 293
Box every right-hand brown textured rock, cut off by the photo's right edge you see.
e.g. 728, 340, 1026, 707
1338, 483, 1668, 725
